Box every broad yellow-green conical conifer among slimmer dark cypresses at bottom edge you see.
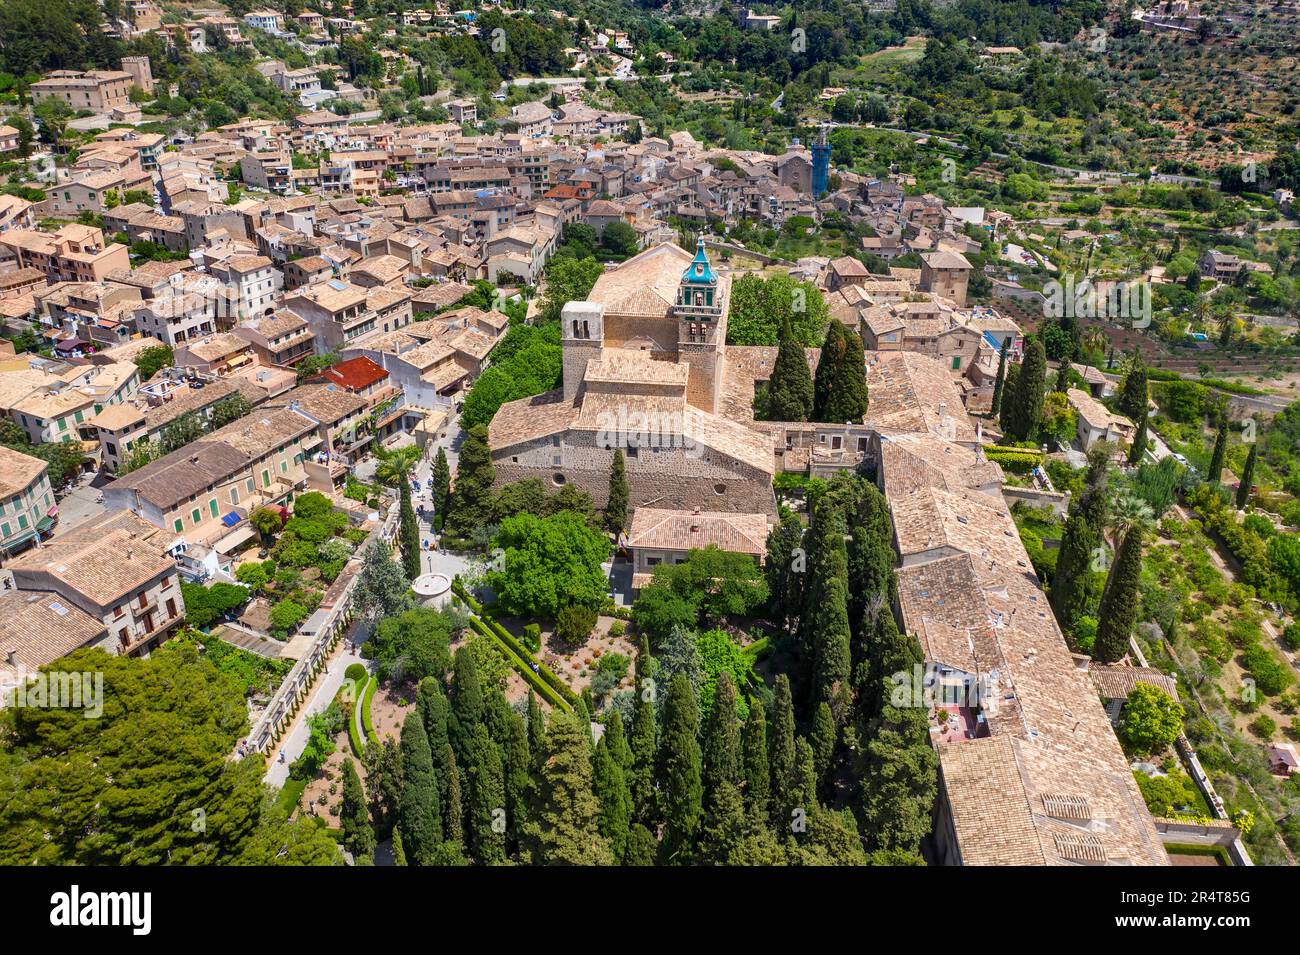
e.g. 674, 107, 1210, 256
525, 709, 614, 865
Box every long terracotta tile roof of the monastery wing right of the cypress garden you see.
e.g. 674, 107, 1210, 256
872, 426, 1169, 865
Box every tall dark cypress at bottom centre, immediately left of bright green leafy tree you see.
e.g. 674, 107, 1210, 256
658, 673, 703, 865
